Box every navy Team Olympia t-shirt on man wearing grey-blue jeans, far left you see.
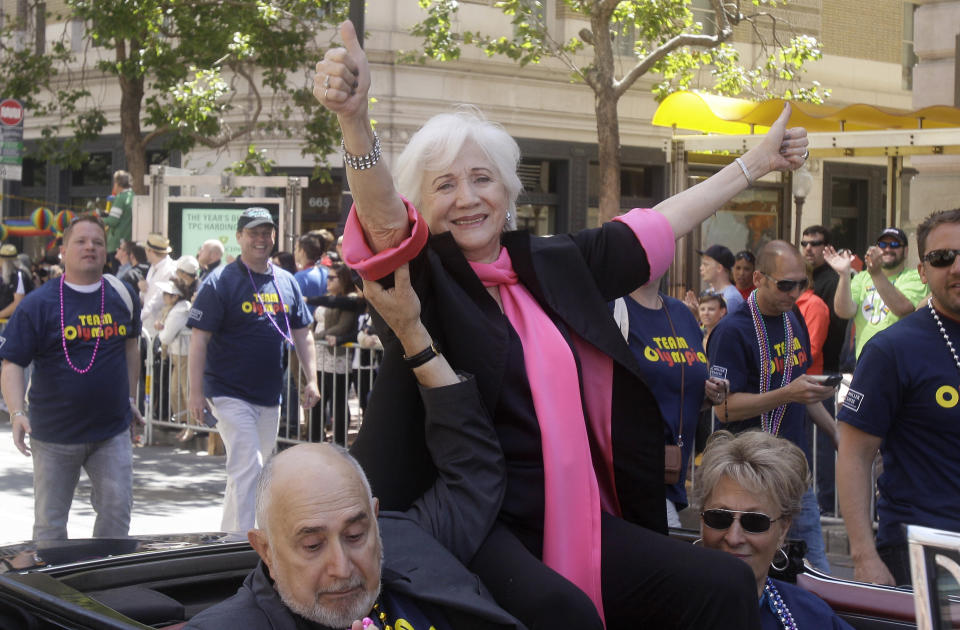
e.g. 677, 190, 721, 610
0, 279, 140, 444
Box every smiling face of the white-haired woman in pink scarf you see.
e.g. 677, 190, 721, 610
420, 141, 509, 262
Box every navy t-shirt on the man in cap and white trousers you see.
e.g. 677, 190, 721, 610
187, 258, 313, 407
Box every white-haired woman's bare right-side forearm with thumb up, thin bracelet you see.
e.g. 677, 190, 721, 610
654, 103, 809, 238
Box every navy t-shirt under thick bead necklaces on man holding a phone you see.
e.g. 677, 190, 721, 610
707, 302, 810, 462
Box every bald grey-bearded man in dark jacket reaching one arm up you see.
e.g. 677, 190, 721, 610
187, 264, 522, 630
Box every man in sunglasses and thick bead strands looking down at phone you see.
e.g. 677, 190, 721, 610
707, 241, 836, 571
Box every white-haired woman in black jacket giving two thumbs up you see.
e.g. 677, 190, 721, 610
314, 22, 807, 629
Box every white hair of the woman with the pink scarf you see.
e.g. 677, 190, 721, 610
394, 105, 523, 229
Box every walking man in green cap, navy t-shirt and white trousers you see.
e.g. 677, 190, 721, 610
187, 208, 320, 532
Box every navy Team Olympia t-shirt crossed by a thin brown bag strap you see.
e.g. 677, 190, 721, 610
624, 295, 708, 507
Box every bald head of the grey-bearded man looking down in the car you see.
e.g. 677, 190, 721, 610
250, 449, 382, 628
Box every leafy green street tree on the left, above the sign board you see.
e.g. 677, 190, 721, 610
0, 0, 346, 193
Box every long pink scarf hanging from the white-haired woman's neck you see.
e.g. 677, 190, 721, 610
470, 248, 603, 619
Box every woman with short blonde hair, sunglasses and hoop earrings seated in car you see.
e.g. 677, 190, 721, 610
697, 431, 852, 630
